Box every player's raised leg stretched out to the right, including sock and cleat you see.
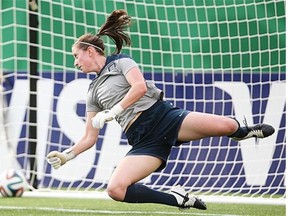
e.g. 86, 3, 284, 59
178, 112, 274, 141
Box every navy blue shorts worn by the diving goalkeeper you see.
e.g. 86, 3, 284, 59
126, 101, 189, 171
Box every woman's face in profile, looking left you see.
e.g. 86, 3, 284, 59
72, 45, 99, 73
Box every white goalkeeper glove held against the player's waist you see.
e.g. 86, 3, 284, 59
92, 103, 124, 129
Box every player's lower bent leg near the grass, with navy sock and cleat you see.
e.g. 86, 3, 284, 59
107, 156, 206, 210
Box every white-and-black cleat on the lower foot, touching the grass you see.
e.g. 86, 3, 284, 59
170, 185, 207, 210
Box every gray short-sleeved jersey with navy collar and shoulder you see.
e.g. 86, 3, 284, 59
86, 54, 163, 129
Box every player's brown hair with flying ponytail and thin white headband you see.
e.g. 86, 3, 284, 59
73, 10, 132, 55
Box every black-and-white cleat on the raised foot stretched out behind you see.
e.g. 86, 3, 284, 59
231, 119, 275, 141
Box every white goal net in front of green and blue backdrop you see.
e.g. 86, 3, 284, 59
0, 0, 286, 203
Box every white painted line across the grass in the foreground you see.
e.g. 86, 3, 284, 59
0, 206, 243, 216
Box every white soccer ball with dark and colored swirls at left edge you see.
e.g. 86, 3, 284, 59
0, 169, 26, 197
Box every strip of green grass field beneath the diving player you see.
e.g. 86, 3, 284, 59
0, 197, 285, 216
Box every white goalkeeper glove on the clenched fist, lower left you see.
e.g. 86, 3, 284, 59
47, 149, 76, 169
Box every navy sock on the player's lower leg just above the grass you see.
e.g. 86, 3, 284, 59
123, 184, 178, 206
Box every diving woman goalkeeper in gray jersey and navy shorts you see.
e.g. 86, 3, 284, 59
47, 10, 274, 210
